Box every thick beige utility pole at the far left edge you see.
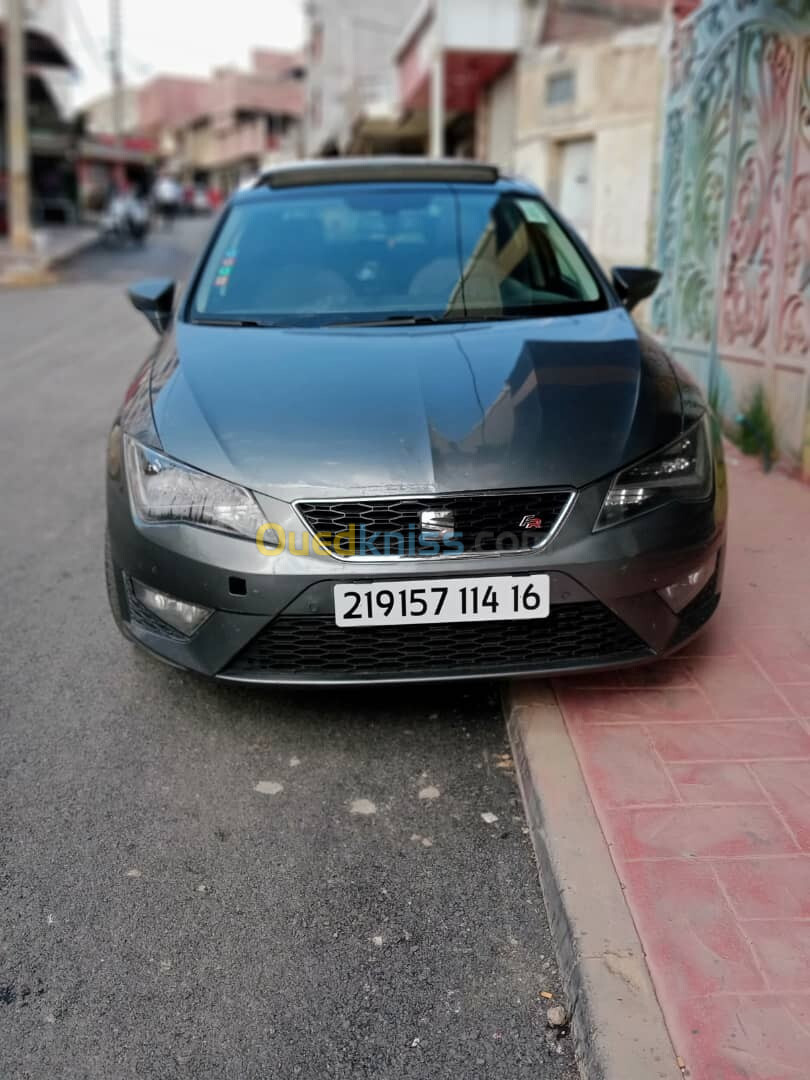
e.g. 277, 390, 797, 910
5, 0, 31, 252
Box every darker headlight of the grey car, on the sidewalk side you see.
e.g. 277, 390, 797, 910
594, 413, 714, 531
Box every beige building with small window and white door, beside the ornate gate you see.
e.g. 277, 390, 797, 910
477, 0, 667, 269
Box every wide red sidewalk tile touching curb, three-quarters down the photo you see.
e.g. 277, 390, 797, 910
605, 806, 798, 860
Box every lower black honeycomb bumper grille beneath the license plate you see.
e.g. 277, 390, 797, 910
221, 602, 652, 679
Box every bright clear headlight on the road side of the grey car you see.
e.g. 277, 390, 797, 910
124, 435, 265, 540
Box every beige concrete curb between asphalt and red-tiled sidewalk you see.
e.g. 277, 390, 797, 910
503, 683, 683, 1080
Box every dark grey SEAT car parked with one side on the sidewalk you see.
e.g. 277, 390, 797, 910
107, 159, 726, 684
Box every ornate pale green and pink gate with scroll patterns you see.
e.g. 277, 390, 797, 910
652, 0, 810, 457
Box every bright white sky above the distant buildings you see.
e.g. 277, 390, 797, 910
63, 0, 303, 105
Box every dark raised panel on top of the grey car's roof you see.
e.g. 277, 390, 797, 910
254, 157, 500, 188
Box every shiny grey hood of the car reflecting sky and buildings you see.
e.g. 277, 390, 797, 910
151, 309, 683, 501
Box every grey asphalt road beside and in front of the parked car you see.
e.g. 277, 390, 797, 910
0, 222, 577, 1080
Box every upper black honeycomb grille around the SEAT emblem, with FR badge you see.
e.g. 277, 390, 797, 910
296, 489, 572, 557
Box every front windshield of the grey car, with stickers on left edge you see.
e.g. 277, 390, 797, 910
190, 185, 607, 326
